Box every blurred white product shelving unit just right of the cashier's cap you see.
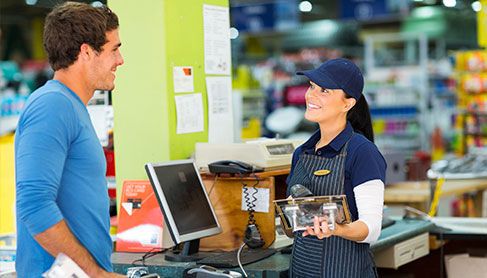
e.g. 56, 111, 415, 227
364, 35, 428, 157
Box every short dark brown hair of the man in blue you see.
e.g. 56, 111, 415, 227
44, 2, 118, 71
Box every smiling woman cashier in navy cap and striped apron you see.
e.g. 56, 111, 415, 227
287, 59, 386, 277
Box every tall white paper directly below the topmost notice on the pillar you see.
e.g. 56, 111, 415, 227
206, 76, 234, 143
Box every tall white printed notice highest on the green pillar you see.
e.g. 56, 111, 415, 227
203, 5, 231, 75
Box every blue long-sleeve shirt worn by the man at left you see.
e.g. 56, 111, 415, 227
15, 80, 112, 277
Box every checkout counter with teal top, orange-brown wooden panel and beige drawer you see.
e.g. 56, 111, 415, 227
112, 165, 434, 277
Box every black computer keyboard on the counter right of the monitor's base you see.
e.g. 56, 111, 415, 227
197, 249, 276, 268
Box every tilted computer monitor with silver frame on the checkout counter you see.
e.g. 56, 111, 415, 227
145, 160, 222, 261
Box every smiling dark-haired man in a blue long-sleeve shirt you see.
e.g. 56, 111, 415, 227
15, 2, 123, 277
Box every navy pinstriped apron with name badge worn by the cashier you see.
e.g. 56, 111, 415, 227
289, 138, 377, 278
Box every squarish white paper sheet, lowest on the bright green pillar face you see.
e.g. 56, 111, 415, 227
174, 94, 204, 134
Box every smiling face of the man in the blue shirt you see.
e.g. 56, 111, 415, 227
90, 29, 123, 91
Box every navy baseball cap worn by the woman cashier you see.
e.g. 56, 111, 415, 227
296, 58, 364, 100
